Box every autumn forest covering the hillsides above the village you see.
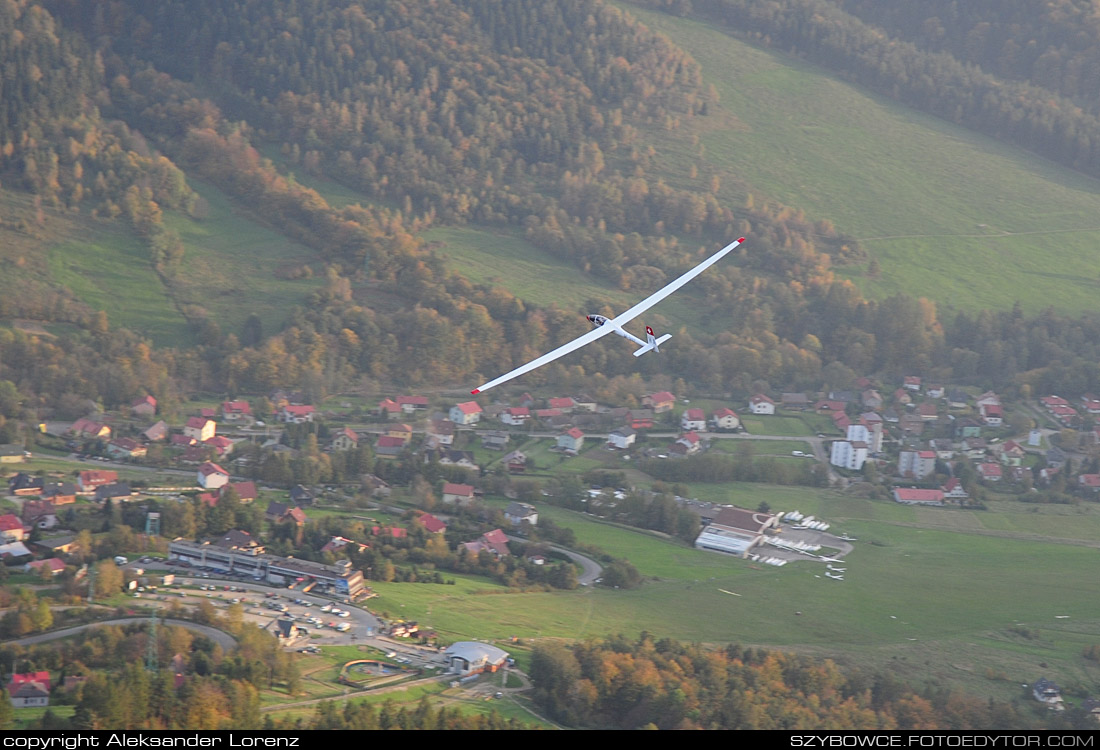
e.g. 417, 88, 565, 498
0, 0, 1100, 412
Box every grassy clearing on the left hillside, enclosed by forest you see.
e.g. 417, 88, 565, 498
0, 180, 320, 345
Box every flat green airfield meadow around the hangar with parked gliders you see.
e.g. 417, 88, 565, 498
372, 484, 1100, 699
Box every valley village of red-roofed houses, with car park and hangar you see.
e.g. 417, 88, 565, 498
0, 376, 1100, 707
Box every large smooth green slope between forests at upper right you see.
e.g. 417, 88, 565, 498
624, 3, 1100, 312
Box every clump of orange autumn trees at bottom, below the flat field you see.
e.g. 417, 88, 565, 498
530, 632, 1088, 730
